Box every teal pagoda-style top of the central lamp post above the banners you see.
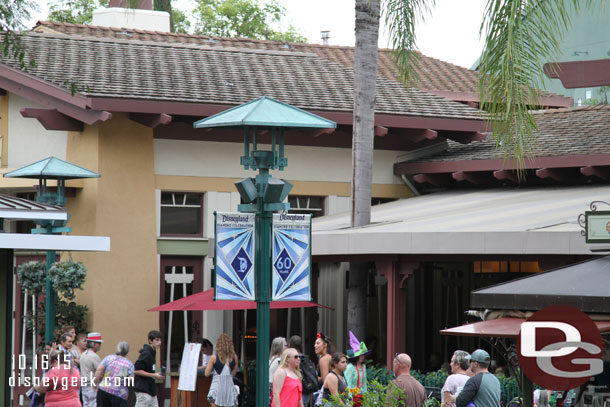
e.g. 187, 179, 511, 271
193, 96, 337, 129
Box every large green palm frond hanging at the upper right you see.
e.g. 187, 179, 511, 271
479, 0, 591, 175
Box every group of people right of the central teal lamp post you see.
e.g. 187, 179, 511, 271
269, 331, 508, 407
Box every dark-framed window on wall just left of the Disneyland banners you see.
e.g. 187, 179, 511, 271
161, 192, 203, 236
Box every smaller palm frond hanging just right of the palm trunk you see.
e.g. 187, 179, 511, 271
382, 0, 434, 86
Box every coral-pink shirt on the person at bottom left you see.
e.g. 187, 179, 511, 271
45, 366, 81, 407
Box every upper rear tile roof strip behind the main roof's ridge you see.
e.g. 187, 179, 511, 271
34, 21, 572, 106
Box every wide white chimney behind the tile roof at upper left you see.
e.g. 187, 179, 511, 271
92, 0, 170, 32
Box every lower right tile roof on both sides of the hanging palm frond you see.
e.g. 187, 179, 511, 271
416, 105, 610, 162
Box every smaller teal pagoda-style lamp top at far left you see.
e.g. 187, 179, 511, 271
4, 157, 100, 206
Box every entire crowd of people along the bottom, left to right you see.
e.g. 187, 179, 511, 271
29, 326, 550, 407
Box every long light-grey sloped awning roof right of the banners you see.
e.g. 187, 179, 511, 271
312, 186, 610, 256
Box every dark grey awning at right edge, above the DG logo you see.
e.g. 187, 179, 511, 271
470, 256, 610, 313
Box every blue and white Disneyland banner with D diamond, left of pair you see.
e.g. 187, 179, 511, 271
214, 212, 255, 300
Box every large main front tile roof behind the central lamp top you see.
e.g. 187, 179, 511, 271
0, 33, 481, 120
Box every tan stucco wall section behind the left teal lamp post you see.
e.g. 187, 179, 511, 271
66, 113, 159, 360
